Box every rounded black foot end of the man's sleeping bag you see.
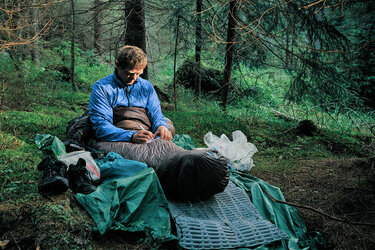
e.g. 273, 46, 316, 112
155, 150, 229, 202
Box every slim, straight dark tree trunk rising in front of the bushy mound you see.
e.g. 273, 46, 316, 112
194, 0, 202, 97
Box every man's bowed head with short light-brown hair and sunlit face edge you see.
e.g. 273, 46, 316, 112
116, 45, 147, 85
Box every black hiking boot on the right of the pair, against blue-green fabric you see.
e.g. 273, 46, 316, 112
68, 158, 96, 194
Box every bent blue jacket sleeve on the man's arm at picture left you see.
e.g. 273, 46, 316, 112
89, 84, 136, 142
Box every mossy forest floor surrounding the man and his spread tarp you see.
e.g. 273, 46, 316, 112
0, 95, 375, 249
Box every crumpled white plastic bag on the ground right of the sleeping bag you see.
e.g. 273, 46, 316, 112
203, 130, 258, 171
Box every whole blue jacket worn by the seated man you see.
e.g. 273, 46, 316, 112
89, 73, 169, 142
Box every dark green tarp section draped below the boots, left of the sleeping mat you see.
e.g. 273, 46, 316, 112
75, 168, 176, 242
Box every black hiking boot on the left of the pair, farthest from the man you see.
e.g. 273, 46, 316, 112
38, 157, 69, 194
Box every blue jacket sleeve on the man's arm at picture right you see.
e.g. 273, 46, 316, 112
146, 83, 169, 133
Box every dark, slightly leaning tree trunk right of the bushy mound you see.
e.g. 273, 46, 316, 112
221, 0, 237, 110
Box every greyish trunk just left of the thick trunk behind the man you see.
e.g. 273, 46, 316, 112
94, 0, 103, 60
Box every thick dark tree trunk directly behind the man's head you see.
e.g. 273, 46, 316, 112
125, 0, 147, 79
